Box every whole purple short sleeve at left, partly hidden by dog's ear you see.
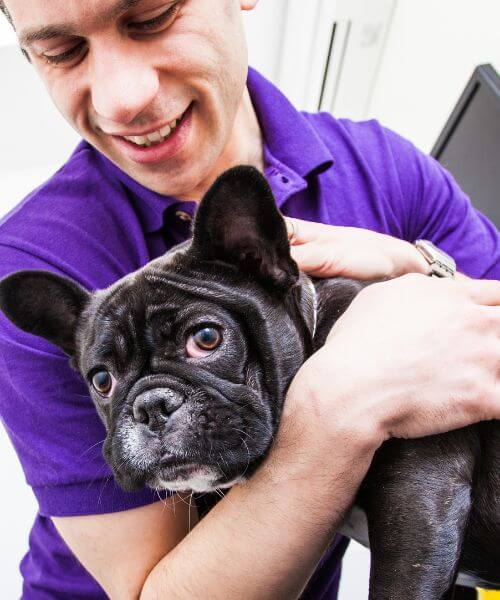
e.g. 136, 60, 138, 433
0, 152, 172, 516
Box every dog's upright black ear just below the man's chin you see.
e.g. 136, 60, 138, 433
191, 166, 299, 289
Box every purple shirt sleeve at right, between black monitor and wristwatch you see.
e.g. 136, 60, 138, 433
385, 130, 500, 279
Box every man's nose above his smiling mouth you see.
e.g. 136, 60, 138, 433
90, 46, 159, 124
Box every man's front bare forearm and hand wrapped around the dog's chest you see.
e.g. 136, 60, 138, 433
52, 275, 500, 600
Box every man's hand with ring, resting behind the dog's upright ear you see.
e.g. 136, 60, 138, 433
285, 217, 429, 279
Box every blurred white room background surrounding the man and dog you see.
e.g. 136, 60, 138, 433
0, 0, 500, 600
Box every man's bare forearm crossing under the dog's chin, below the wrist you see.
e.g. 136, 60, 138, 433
141, 418, 373, 600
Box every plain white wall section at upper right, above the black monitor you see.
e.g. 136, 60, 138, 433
367, 0, 500, 151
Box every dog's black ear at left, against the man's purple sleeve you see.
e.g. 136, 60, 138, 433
0, 271, 91, 356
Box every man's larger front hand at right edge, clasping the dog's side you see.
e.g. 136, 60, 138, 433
278, 275, 500, 463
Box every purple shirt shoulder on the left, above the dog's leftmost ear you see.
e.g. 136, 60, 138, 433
0, 143, 146, 287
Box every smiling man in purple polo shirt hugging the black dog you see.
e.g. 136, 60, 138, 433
0, 0, 500, 599
